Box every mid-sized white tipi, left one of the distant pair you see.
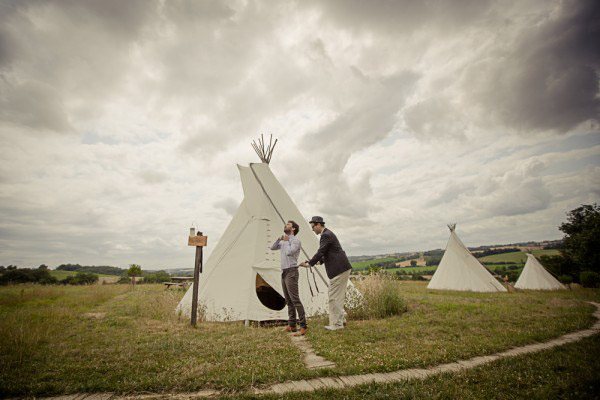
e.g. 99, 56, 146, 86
427, 224, 506, 292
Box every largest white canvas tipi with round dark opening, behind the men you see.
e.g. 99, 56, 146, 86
177, 142, 336, 321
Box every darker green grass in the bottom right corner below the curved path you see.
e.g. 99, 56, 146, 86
229, 335, 600, 400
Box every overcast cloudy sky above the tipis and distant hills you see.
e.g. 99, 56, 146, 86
0, 0, 600, 269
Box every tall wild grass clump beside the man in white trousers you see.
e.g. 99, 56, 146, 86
347, 273, 408, 319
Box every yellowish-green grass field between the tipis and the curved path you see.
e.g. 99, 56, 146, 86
0, 281, 600, 398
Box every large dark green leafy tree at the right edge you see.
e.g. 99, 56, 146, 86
559, 203, 600, 272
